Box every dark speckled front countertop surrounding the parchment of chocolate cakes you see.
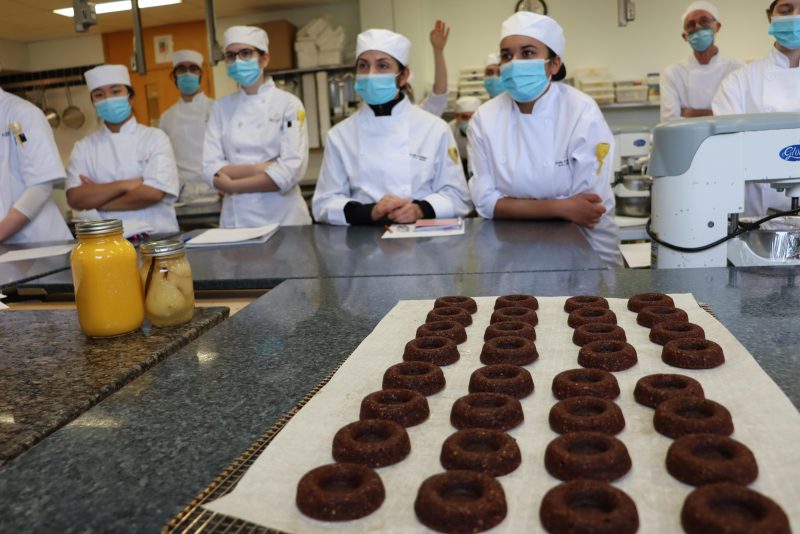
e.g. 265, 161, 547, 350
0, 268, 800, 532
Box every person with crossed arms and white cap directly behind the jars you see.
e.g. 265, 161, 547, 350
66, 65, 179, 234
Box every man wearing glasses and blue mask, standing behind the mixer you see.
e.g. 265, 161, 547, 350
661, 1, 744, 121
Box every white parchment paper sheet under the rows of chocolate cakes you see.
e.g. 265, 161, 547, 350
206, 294, 800, 533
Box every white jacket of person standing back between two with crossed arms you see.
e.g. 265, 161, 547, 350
159, 92, 216, 201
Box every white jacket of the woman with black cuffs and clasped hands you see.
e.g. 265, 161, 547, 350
312, 98, 471, 224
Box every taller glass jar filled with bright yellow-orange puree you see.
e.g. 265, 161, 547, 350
70, 219, 144, 337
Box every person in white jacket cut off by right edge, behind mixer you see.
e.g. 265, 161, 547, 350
713, 0, 800, 216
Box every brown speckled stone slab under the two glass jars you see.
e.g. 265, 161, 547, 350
0, 308, 228, 466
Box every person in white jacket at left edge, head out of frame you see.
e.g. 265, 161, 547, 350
0, 89, 72, 244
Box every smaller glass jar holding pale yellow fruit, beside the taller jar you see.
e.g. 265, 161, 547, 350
139, 239, 194, 326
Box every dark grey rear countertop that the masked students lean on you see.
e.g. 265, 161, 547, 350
12, 218, 605, 293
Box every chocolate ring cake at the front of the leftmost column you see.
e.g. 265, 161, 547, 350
295, 464, 386, 521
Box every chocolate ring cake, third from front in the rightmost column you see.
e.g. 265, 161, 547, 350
653, 397, 733, 439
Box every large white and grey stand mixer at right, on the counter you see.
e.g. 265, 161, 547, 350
649, 113, 800, 268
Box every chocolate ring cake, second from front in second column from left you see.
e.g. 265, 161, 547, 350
439, 428, 522, 477
